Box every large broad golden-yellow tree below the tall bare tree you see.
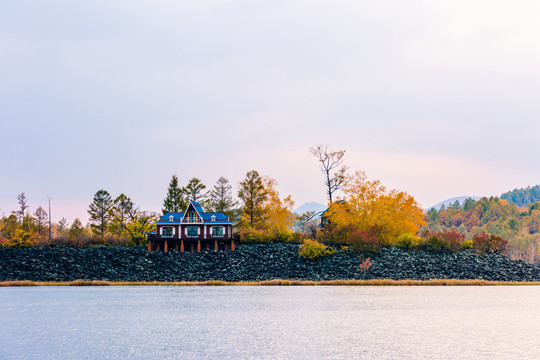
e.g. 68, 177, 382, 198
327, 171, 425, 245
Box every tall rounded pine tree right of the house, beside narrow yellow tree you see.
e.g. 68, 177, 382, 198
238, 170, 267, 227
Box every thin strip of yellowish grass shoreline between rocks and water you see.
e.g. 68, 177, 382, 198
0, 279, 540, 287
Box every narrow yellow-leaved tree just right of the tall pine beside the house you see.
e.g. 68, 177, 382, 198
263, 177, 295, 240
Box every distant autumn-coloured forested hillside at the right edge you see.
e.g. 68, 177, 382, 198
422, 197, 540, 263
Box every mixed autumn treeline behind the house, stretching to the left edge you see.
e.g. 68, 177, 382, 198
0, 170, 304, 247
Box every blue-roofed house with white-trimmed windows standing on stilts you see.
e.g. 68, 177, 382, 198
148, 201, 237, 252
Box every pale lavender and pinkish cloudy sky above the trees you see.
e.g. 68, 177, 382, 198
0, 0, 540, 223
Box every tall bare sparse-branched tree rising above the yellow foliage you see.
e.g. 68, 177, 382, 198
309, 145, 348, 204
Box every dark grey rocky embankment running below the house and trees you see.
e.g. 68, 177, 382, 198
0, 243, 540, 281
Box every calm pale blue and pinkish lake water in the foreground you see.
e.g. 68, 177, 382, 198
0, 286, 540, 360
